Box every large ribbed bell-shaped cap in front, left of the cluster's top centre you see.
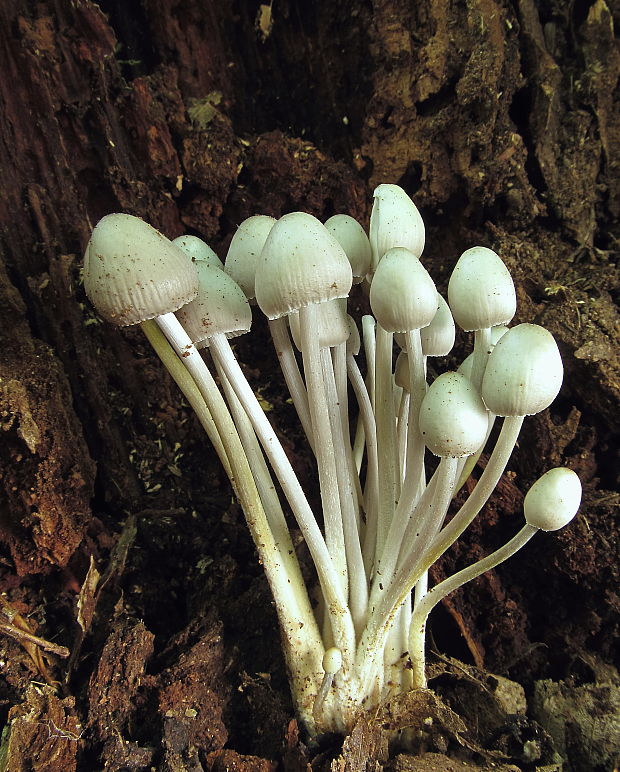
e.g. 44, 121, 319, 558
256, 212, 353, 319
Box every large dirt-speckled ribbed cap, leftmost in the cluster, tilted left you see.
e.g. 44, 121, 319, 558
84, 214, 198, 326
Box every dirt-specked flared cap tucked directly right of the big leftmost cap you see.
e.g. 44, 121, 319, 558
177, 261, 252, 346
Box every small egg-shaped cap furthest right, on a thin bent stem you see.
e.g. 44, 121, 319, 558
523, 466, 581, 531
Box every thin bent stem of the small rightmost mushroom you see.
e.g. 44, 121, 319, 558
409, 525, 539, 689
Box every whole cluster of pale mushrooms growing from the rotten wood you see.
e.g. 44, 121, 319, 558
84, 185, 581, 734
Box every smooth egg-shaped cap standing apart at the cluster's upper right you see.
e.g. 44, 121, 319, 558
448, 247, 517, 332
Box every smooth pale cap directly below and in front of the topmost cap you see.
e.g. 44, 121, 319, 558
370, 247, 437, 332
